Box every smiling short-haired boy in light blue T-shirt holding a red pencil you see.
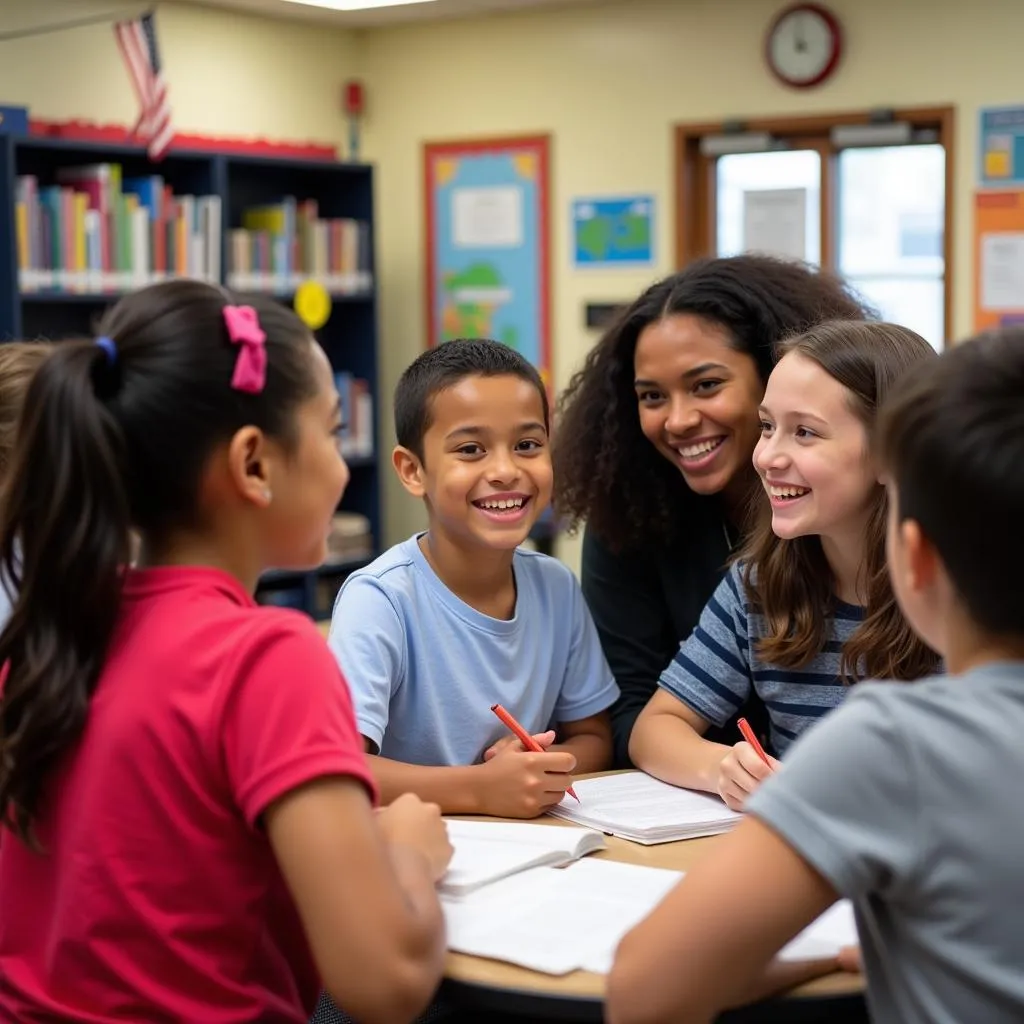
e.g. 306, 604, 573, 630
329, 340, 618, 817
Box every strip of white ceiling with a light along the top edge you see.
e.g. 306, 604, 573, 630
183, 0, 608, 28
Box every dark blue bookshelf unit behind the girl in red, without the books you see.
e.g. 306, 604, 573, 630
0, 134, 382, 617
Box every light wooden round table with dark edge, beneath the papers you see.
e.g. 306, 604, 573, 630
441, 773, 867, 1024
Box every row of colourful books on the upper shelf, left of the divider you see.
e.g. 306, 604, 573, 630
14, 164, 222, 293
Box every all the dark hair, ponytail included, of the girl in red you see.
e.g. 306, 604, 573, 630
0, 280, 316, 840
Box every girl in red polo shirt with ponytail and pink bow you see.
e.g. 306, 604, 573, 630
0, 280, 452, 1024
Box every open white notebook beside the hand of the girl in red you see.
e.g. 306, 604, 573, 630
440, 819, 604, 896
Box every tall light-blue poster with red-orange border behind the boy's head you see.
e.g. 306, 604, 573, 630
424, 136, 551, 389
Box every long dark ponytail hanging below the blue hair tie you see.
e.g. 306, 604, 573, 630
0, 341, 130, 846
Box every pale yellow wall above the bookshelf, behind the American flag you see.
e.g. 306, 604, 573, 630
0, 0, 355, 142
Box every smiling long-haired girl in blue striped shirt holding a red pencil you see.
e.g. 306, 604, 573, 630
630, 321, 937, 810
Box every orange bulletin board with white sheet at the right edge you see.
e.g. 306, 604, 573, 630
974, 189, 1024, 331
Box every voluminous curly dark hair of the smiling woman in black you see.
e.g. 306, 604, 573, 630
552, 255, 873, 551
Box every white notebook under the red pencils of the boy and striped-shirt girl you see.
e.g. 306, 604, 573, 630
549, 771, 742, 846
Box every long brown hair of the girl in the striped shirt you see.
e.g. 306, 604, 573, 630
737, 321, 938, 682
